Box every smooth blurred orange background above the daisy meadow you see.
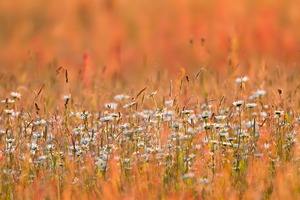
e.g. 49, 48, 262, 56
0, 0, 300, 75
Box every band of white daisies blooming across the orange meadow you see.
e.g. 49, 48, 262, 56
0, 77, 300, 188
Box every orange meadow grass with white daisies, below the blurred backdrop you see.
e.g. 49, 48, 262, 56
0, 65, 300, 199
